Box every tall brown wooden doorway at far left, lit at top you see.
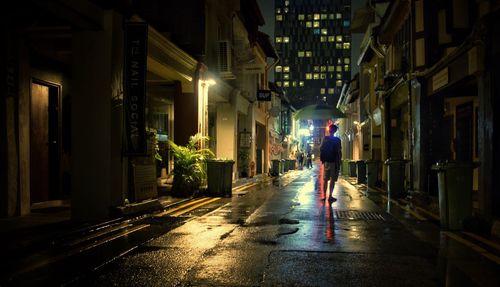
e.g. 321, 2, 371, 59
30, 80, 61, 204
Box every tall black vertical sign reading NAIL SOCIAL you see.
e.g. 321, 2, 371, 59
123, 22, 148, 156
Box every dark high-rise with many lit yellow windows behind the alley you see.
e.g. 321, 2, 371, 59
274, 0, 352, 108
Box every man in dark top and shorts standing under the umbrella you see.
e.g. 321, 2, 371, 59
320, 124, 342, 202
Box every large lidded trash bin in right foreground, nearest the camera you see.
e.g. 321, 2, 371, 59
432, 162, 474, 230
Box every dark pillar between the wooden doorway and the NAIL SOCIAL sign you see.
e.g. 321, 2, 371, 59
71, 11, 123, 221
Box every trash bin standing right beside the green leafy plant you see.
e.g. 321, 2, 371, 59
207, 160, 234, 197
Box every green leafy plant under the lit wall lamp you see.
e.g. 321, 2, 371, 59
168, 134, 215, 197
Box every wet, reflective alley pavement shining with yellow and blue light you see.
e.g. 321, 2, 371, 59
3, 163, 500, 286
